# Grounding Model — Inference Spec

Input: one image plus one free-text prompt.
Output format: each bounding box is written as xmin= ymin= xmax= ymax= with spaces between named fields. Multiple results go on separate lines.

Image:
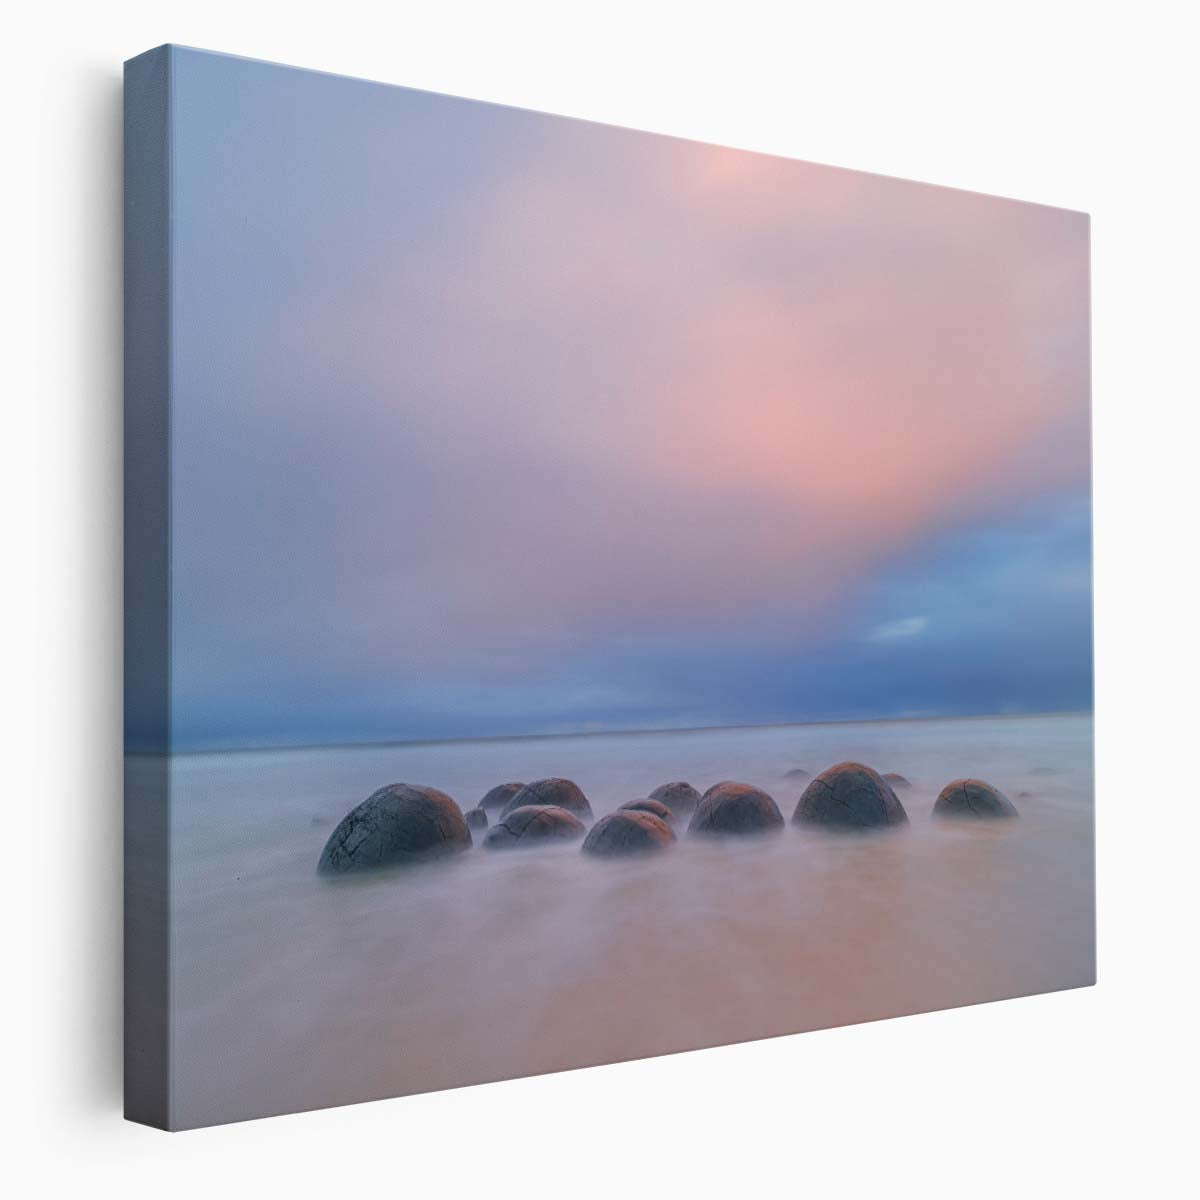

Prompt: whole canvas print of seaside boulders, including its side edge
xmin=126 ymin=47 xmax=1094 ymax=1129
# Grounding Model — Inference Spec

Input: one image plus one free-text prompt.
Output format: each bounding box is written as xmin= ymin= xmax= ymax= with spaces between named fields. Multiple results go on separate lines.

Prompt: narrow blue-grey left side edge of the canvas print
xmin=125 ymin=47 xmax=170 ymax=1128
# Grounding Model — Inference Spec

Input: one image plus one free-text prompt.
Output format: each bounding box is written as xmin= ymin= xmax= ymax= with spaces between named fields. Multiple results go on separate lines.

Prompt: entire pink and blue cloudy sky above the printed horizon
xmin=147 ymin=52 xmax=1092 ymax=749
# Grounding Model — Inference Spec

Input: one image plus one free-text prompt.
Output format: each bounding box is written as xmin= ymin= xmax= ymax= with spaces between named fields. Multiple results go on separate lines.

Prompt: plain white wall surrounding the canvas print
xmin=11 ymin=0 xmax=1200 ymax=1196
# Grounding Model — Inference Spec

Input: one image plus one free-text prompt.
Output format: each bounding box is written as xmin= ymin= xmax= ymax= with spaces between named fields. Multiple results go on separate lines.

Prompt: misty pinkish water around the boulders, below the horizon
xmin=159 ymin=715 xmax=1094 ymax=1126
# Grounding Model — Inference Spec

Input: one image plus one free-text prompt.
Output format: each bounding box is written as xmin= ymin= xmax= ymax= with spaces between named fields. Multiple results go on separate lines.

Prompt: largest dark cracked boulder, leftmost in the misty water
xmin=317 ymin=784 xmax=472 ymax=874
